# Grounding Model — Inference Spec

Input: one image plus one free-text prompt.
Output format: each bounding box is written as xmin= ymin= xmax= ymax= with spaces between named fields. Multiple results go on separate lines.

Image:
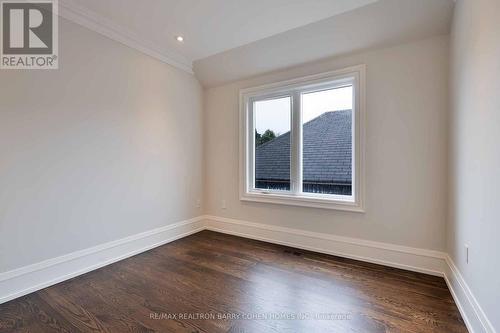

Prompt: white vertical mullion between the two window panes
xmin=290 ymin=91 xmax=302 ymax=195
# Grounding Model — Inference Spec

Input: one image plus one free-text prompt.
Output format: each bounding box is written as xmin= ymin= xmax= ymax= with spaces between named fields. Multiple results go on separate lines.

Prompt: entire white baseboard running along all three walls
xmin=0 ymin=215 xmax=496 ymax=333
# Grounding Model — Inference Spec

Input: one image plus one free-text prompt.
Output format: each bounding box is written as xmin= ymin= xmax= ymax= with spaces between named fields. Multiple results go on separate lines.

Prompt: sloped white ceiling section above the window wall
xmin=194 ymin=0 xmax=454 ymax=86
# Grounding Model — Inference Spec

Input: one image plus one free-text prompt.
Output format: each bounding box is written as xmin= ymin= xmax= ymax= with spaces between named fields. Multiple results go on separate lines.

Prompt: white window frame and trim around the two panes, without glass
xmin=239 ymin=65 xmax=366 ymax=212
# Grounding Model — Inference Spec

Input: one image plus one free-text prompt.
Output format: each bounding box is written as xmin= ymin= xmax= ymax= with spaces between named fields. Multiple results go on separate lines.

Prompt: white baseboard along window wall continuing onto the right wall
xmin=204 ymin=215 xmax=496 ymax=333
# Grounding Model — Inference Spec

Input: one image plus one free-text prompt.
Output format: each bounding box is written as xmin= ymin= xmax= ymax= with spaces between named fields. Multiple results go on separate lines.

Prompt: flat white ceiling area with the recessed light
xmin=60 ymin=0 xmax=377 ymax=67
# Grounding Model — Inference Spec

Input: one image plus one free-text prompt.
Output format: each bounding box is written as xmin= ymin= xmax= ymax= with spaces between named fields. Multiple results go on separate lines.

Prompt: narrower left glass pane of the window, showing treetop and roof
xmin=254 ymin=97 xmax=291 ymax=191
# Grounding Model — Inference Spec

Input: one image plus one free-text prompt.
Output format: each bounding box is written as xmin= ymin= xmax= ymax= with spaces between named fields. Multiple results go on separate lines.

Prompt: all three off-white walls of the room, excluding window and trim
xmin=0 ymin=4 xmax=500 ymax=330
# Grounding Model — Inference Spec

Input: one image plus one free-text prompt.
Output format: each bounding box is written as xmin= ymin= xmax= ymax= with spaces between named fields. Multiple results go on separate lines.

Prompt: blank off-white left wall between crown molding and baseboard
xmin=0 ymin=19 xmax=203 ymax=272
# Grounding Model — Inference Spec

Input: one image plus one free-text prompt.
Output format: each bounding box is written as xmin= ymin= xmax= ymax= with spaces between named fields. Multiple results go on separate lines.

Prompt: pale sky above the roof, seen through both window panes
xmin=254 ymin=86 xmax=352 ymax=135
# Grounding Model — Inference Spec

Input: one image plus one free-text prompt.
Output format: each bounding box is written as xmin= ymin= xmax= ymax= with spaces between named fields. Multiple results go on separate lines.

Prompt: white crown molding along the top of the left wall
xmin=59 ymin=0 xmax=194 ymax=74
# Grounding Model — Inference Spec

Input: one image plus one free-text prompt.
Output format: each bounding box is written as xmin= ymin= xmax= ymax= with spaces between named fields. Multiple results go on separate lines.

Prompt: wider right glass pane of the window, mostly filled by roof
xmin=302 ymin=86 xmax=353 ymax=195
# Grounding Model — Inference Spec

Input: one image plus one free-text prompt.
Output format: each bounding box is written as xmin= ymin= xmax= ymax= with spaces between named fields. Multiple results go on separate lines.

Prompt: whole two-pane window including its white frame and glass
xmin=240 ymin=66 xmax=365 ymax=211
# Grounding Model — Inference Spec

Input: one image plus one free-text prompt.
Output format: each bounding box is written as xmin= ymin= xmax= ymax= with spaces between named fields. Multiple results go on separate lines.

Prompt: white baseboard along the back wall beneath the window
xmin=205 ymin=216 xmax=446 ymax=276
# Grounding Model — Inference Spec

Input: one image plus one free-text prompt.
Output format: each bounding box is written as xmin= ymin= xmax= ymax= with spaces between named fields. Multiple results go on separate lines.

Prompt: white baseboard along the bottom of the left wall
xmin=0 ymin=217 xmax=204 ymax=304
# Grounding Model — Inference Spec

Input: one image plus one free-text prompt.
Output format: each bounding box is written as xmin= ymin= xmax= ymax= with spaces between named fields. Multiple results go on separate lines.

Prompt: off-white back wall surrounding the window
xmin=204 ymin=36 xmax=448 ymax=250
